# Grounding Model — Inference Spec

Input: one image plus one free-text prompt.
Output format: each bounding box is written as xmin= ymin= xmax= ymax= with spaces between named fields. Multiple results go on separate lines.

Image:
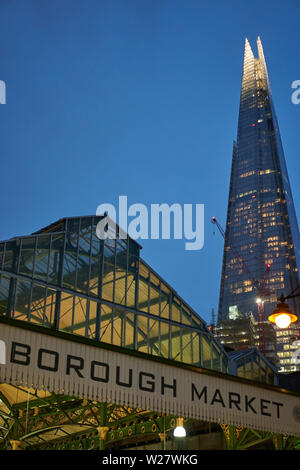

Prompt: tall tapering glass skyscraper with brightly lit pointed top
xmin=218 ymin=38 xmax=300 ymax=370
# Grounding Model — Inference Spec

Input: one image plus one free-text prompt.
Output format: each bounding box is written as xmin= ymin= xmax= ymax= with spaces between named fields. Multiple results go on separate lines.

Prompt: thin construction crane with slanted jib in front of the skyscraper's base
xmin=211 ymin=217 xmax=271 ymax=355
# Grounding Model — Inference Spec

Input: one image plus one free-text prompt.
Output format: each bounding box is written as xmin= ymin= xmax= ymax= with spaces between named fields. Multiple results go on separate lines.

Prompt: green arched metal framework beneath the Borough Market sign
xmin=0 ymin=384 xmax=300 ymax=450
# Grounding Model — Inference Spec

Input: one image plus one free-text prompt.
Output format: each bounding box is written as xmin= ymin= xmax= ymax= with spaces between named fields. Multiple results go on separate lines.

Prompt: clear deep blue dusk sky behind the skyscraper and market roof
xmin=0 ymin=0 xmax=300 ymax=322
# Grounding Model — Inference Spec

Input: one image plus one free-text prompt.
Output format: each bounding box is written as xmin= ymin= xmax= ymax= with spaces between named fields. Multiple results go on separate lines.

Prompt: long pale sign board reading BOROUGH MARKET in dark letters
xmin=0 ymin=323 xmax=300 ymax=436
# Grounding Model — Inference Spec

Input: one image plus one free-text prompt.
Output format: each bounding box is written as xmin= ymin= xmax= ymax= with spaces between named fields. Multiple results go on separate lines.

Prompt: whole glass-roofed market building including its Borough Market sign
xmin=0 ymin=216 xmax=300 ymax=449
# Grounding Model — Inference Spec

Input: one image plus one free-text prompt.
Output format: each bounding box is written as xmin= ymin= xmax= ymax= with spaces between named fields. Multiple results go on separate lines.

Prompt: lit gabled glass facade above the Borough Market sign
xmin=0 ymin=216 xmax=227 ymax=372
